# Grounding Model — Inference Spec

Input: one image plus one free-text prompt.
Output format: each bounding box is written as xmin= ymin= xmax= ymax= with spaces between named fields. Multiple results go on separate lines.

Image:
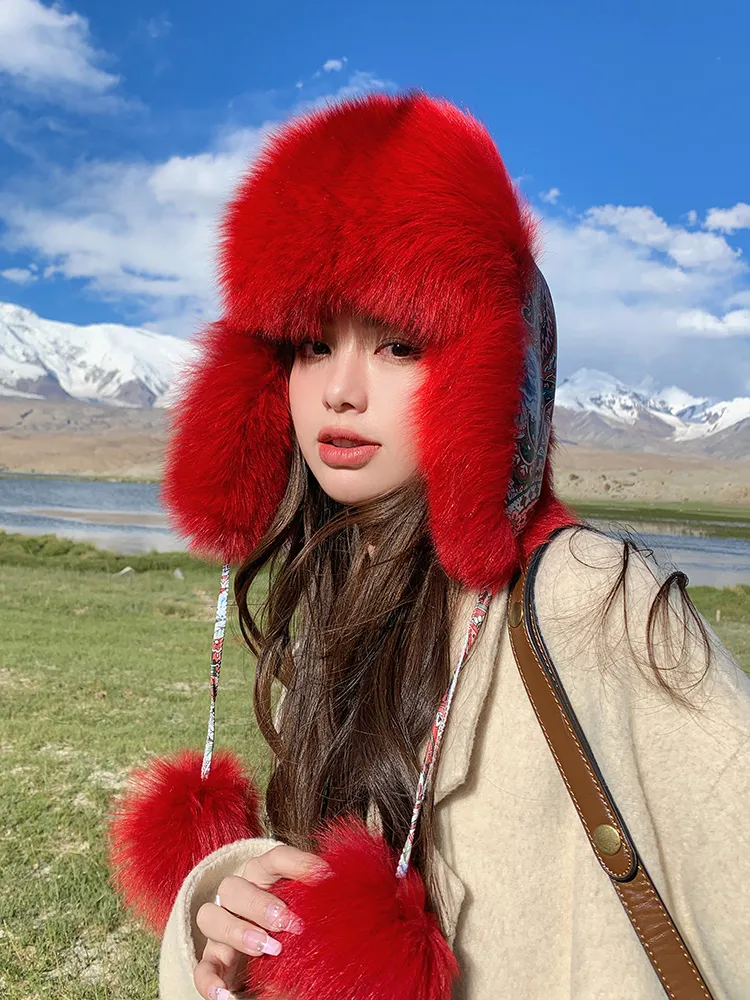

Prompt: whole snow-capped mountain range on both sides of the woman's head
xmin=0 ymin=303 xmax=750 ymax=459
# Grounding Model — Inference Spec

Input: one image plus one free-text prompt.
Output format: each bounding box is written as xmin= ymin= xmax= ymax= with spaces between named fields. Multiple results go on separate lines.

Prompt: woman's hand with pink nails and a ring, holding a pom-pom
xmin=193 ymin=844 xmax=327 ymax=1000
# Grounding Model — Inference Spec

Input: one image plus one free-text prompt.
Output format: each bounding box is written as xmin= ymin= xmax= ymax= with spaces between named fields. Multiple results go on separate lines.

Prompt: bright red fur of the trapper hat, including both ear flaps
xmin=162 ymin=92 xmax=572 ymax=588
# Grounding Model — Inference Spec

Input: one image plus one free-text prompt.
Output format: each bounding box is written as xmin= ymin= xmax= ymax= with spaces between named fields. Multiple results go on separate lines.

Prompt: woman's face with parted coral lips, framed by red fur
xmin=289 ymin=316 xmax=425 ymax=504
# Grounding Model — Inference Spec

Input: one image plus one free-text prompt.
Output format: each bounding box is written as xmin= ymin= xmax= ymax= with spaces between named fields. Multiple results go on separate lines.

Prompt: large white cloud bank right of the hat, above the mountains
xmin=540 ymin=205 xmax=750 ymax=398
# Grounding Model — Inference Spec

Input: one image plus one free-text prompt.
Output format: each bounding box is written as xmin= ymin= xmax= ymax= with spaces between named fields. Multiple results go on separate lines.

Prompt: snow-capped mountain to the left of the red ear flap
xmin=0 ymin=303 xmax=195 ymax=407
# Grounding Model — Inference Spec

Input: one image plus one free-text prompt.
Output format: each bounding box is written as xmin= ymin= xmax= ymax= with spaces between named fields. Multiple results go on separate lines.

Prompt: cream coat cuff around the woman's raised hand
xmin=159 ymin=837 xmax=280 ymax=1000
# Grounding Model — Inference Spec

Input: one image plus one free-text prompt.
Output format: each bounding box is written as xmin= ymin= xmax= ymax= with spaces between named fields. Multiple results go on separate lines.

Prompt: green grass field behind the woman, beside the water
xmin=0 ymin=533 xmax=750 ymax=1000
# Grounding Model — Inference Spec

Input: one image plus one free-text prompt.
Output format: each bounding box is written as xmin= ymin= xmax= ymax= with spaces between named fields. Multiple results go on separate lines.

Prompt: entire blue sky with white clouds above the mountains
xmin=0 ymin=0 xmax=750 ymax=398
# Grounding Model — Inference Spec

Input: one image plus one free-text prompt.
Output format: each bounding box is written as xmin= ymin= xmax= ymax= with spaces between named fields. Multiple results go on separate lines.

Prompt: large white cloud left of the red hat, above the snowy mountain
xmin=0 ymin=129 xmax=270 ymax=333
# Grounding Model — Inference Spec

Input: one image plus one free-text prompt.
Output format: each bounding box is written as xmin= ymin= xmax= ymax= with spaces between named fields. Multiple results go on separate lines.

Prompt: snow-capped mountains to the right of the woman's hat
xmin=555 ymin=368 xmax=750 ymax=458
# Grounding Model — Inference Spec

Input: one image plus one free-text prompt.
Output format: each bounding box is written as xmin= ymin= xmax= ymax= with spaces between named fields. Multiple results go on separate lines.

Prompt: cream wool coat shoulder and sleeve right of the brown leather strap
xmin=537 ymin=531 xmax=750 ymax=1000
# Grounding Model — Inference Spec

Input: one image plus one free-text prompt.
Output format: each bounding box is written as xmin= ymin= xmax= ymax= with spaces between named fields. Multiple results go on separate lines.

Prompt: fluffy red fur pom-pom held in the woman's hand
xmin=247 ymin=818 xmax=458 ymax=1000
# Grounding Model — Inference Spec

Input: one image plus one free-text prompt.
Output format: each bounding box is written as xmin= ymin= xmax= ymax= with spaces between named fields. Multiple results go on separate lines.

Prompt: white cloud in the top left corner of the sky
xmin=0 ymin=0 xmax=120 ymax=109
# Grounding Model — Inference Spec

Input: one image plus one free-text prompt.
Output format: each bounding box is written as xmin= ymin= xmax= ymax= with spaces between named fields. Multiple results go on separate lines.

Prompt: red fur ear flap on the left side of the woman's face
xmin=160 ymin=322 xmax=293 ymax=563
